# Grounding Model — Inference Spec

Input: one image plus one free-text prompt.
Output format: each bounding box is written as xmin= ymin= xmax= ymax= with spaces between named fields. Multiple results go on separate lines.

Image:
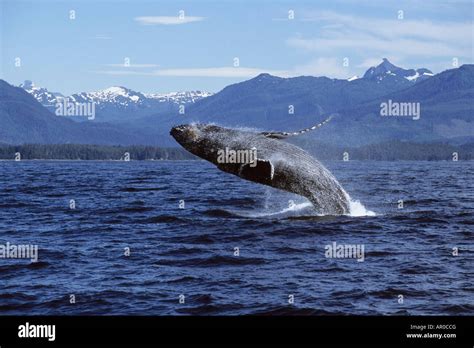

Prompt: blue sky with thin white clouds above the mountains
xmin=0 ymin=0 xmax=474 ymax=95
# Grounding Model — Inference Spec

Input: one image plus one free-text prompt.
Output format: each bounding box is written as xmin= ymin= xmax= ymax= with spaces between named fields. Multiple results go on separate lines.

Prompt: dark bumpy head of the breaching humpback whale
xmin=170 ymin=124 xmax=229 ymax=163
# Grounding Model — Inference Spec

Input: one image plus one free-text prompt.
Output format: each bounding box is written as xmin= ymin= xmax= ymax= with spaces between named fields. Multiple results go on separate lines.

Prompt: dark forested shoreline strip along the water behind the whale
xmin=0 ymin=139 xmax=474 ymax=162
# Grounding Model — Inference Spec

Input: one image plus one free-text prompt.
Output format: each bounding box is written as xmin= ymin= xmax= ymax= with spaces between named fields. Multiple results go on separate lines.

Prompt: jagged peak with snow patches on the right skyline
xmin=363 ymin=58 xmax=434 ymax=82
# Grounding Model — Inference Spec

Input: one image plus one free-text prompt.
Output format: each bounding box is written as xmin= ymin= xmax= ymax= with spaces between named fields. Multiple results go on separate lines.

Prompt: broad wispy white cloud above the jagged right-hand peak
xmin=287 ymin=11 xmax=474 ymax=59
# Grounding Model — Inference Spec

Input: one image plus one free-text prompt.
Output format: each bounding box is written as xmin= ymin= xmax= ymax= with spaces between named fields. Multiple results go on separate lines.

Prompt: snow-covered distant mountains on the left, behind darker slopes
xmin=20 ymin=81 xmax=212 ymax=122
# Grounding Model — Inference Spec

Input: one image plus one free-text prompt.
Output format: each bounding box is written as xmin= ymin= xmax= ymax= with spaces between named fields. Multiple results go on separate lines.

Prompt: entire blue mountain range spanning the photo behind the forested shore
xmin=0 ymin=59 xmax=474 ymax=147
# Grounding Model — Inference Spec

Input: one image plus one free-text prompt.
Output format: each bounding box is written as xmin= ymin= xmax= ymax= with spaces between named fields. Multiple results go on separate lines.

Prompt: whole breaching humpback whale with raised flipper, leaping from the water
xmin=170 ymin=118 xmax=350 ymax=215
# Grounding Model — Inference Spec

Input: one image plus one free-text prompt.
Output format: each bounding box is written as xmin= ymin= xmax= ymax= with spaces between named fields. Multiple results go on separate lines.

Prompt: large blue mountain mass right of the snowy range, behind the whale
xmin=180 ymin=59 xmax=474 ymax=146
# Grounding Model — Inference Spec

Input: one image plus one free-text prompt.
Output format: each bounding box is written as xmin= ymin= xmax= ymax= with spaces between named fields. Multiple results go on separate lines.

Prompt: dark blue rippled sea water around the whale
xmin=0 ymin=161 xmax=474 ymax=315
